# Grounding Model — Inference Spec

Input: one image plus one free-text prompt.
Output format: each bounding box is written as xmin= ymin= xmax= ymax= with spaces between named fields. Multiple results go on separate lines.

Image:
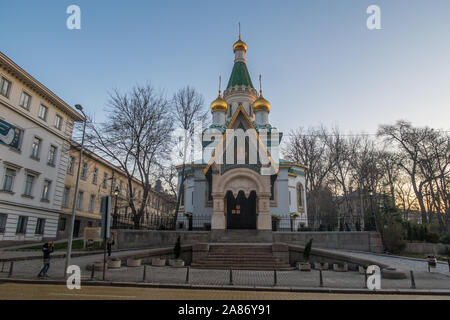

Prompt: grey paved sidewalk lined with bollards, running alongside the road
xmin=0 ymin=253 xmax=450 ymax=290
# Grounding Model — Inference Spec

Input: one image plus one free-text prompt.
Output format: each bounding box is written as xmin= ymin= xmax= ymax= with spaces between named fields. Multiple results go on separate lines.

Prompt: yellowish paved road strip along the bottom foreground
xmin=0 ymin=283 xmax=450 ymax=300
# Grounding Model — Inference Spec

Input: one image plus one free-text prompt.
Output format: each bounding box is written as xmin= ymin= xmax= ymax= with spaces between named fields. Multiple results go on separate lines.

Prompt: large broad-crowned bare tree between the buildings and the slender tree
xmin=86 ymin=85 xmax=173 ymax=228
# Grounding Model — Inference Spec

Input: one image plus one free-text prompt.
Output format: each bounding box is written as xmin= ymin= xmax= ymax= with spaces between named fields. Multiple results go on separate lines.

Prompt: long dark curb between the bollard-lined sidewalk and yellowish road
xmin=0 ymin=278 xmax=450 ymax=296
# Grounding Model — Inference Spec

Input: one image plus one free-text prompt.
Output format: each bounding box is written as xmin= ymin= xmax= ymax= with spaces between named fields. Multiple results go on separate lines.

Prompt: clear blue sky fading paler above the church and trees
xmin=0 ymin=0 xmax=450 ymax=133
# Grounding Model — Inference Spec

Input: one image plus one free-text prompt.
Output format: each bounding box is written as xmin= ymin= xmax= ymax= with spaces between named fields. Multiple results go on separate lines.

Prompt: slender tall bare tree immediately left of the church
xmin=172 ymin=86 xmax=208 ymax=225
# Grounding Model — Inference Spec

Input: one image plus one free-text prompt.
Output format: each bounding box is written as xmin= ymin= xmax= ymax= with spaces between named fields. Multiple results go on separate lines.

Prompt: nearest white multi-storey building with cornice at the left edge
xmin=0 ymin=52 xmax=84 ymax=241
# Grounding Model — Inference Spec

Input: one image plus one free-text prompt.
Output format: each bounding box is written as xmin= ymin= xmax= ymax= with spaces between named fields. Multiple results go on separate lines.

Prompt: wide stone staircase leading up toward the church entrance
xmin=191 ymin=244 xmax=294 ymax=270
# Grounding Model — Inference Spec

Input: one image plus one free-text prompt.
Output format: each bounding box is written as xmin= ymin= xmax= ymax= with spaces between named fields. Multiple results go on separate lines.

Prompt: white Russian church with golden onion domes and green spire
xmin=177 ymin=32 xmax=308 ymax=231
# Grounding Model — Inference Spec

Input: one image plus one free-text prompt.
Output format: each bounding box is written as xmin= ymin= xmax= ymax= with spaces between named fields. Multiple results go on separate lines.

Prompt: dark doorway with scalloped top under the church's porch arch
xmin=226 ymin=190 xmax=256 ymax=229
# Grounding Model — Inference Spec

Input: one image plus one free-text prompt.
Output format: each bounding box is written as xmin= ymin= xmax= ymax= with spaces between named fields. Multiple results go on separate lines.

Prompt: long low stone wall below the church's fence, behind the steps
xmin=117 ymin=230 xmax=383 ymax=252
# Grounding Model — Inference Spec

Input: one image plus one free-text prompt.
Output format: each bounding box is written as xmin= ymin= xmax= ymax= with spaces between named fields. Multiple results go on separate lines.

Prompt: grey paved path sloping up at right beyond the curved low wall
xmin=341 ymin=251 xmax=450 ymax=275
